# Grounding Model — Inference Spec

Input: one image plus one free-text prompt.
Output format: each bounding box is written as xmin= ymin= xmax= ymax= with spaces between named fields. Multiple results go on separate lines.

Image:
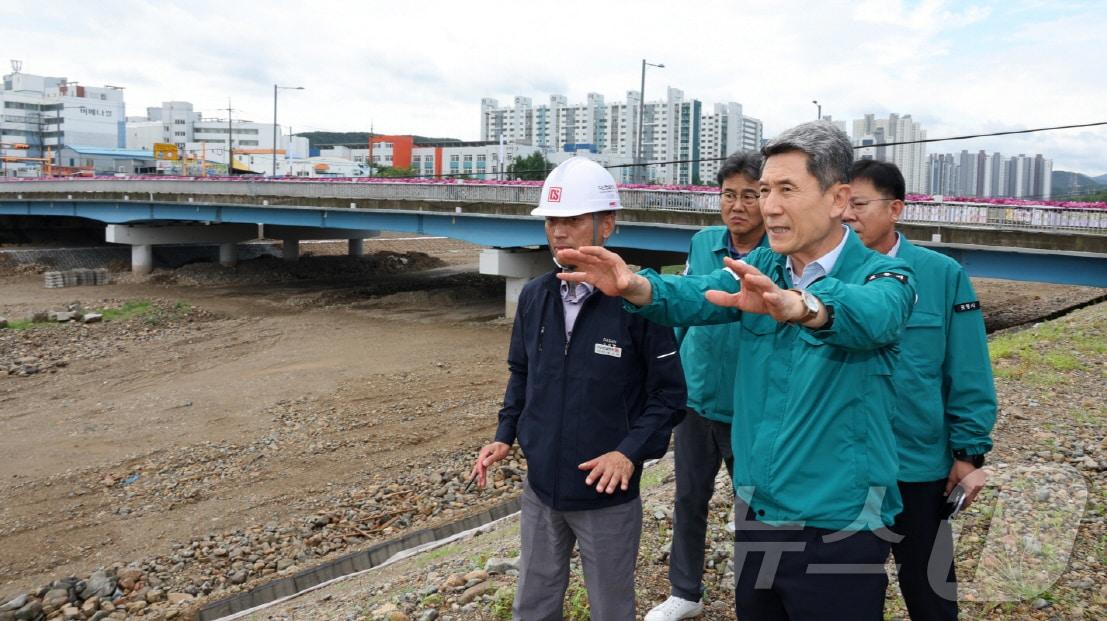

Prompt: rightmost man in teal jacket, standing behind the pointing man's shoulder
xmin=844 ymin=159 xmax=995 ymax=621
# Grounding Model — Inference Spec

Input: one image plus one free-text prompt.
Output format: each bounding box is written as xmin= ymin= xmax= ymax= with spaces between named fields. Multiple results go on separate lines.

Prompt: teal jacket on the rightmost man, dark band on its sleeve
xmin=892 ymin=236 xmax=995 ymax=483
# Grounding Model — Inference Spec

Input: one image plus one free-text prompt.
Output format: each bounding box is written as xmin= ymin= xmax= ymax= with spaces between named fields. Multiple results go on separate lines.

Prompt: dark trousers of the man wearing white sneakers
xmin=669 ymin=410 xmax=734 ymax=601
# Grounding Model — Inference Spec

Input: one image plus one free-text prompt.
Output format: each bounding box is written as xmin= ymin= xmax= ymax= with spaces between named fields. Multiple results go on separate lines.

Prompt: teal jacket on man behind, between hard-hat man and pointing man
xmin=676 ymin=226 xmax=768 ymax=425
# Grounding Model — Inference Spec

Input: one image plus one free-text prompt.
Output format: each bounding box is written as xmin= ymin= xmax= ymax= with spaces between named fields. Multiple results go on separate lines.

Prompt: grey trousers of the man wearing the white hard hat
xmin=511 ymin=482 xmax=642 ymax=621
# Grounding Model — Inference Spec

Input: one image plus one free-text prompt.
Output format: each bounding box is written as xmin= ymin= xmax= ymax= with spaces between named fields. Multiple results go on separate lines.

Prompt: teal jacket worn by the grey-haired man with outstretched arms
xmin=627 ymin=231 xmax=914 ymax=530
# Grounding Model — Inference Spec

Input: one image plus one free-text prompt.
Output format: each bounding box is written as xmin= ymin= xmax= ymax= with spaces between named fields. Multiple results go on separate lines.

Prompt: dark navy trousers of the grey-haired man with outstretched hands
xmin=734 ymin=503 xmax=890 ymax=621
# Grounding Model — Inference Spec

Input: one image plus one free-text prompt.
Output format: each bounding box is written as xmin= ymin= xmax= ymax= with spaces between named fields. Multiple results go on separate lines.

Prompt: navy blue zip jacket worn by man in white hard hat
xmin=496 ymin=272 xmax=686 ymax=510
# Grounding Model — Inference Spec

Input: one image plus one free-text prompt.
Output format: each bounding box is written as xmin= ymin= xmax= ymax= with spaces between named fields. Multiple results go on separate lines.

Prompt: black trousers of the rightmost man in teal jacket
xmin=892 ymin=478 xmax=958 ymax=621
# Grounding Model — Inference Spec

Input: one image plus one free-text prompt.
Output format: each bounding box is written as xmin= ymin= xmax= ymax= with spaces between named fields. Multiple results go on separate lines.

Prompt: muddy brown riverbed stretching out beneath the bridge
xmin=0 ymin=234 xmax=1104 ymax=615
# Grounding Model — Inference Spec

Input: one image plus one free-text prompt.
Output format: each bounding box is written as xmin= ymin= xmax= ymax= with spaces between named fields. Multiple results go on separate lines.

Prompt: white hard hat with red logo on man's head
xmin=530 ymin=156 xmax=622 ymax=218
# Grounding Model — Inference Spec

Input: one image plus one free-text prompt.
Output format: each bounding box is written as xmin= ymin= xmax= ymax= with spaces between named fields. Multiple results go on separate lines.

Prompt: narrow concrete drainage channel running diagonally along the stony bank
xmin=196 ymin=498 xmax=519 ymax=621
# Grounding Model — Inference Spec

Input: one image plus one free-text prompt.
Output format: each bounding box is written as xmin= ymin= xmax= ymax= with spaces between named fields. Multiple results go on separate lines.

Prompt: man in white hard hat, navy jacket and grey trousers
xmin=473 ymin=157 xmax=685 ymax=621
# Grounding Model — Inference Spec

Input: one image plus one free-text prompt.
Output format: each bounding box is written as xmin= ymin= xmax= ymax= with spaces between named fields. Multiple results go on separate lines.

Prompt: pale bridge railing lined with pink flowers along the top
xmin=0 ymin=178 xmax=1107 ymax=234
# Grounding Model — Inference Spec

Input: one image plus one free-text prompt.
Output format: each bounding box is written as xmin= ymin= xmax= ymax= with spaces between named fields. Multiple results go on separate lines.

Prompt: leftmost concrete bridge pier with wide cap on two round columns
xmin=104 ymin=224 xmax=258 ymax=275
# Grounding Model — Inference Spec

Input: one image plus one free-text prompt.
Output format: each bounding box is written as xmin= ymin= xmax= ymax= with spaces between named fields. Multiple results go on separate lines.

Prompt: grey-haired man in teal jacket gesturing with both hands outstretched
xmin=558 ymin=122 xmax=915 ymax=620
